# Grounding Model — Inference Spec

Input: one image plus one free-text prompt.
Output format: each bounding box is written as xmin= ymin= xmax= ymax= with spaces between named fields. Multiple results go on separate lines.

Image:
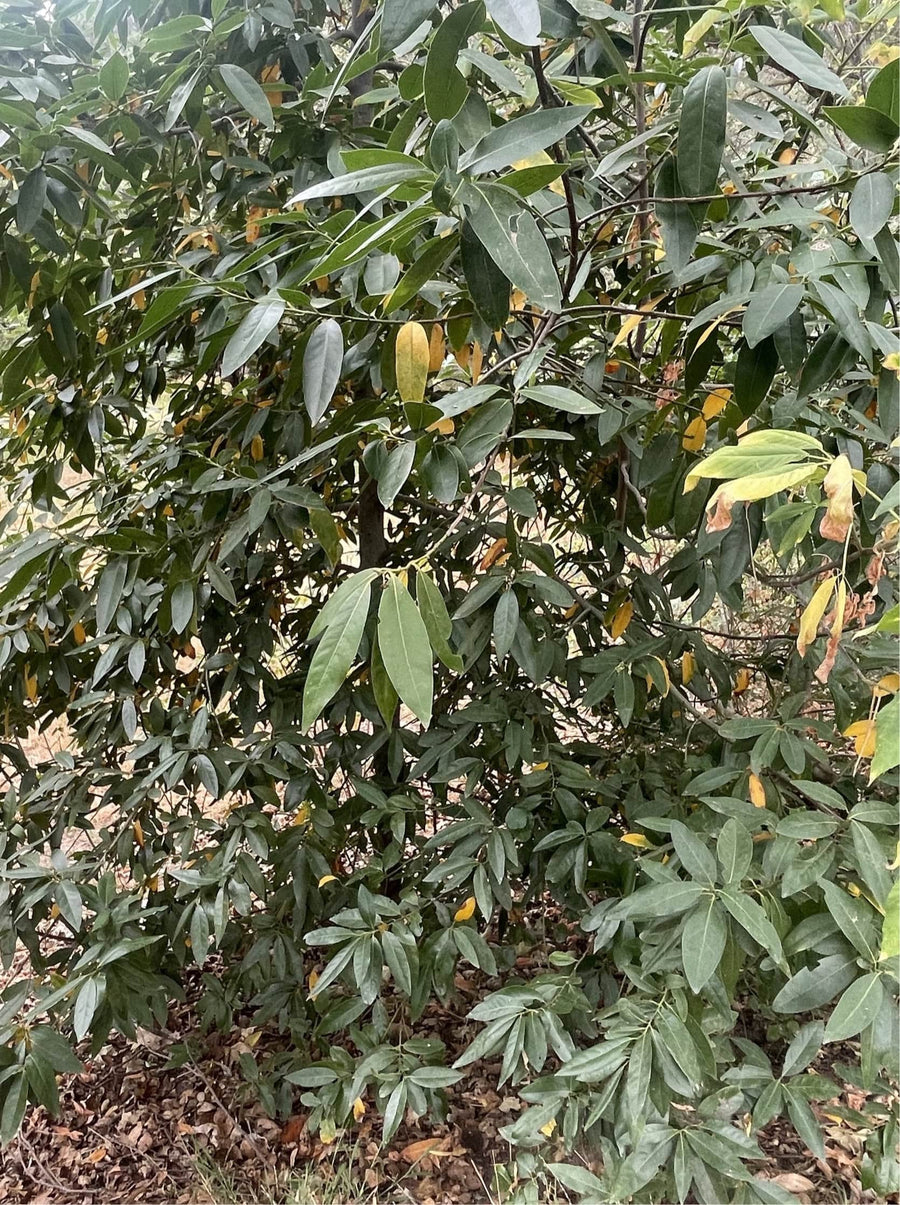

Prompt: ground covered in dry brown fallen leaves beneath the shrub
xmin=0 ymin=949 xmax=878 ymax=1205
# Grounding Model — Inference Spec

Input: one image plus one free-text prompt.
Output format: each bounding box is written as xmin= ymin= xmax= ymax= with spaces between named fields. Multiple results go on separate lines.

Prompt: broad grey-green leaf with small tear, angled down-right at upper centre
xmin=460 ymin=184 xmax=563 ymax=313
